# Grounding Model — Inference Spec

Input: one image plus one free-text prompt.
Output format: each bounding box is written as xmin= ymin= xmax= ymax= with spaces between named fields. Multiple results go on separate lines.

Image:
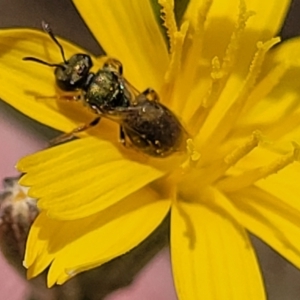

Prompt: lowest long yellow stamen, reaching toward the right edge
xmin=217 ymin=143 xmax=300 ymax=192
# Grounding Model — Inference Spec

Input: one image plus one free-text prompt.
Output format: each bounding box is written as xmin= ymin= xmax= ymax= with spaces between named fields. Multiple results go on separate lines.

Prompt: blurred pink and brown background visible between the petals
xmin=0 ymin=0 xmax=300 ymax=300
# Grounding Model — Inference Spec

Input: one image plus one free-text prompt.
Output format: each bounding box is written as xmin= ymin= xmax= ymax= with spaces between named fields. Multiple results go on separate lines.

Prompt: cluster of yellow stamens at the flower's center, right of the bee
xmin=159 ymin=0 xmax=300 ymax=204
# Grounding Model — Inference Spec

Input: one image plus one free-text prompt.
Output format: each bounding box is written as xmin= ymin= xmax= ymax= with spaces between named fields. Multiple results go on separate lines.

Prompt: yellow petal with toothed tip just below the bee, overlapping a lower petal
xmin=18 ymin=137 xmax=164 ymax=220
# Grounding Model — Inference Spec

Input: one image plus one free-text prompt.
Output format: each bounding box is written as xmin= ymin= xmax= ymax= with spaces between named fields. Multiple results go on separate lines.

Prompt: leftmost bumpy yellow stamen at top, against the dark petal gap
xmin=158 ymin=0 xmax=177 ymax=54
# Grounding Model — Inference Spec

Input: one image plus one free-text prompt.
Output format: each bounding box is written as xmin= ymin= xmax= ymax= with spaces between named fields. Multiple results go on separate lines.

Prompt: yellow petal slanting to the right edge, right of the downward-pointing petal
xmin=230 ymin=187 xmax=300 ymax=268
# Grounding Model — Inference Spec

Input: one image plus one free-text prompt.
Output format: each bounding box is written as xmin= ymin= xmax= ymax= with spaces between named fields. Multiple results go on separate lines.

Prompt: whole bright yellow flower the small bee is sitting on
xmin=0 ymin=0 xmax=300 ymax=300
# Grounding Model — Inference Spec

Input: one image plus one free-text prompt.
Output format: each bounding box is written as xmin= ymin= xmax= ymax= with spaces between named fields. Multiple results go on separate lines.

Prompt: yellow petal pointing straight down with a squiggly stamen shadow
xmin=171 ymin=191 xmax=265 ymax=300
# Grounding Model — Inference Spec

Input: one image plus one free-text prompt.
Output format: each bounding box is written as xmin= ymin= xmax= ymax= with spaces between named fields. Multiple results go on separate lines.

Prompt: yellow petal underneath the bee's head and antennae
xmin=0 ymin=29 xmax=104 ymax=131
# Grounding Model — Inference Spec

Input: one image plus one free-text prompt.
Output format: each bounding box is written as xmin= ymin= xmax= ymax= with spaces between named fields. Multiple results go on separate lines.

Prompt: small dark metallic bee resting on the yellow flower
xmin=23 ymin=22 xmax=186 ymax=157
